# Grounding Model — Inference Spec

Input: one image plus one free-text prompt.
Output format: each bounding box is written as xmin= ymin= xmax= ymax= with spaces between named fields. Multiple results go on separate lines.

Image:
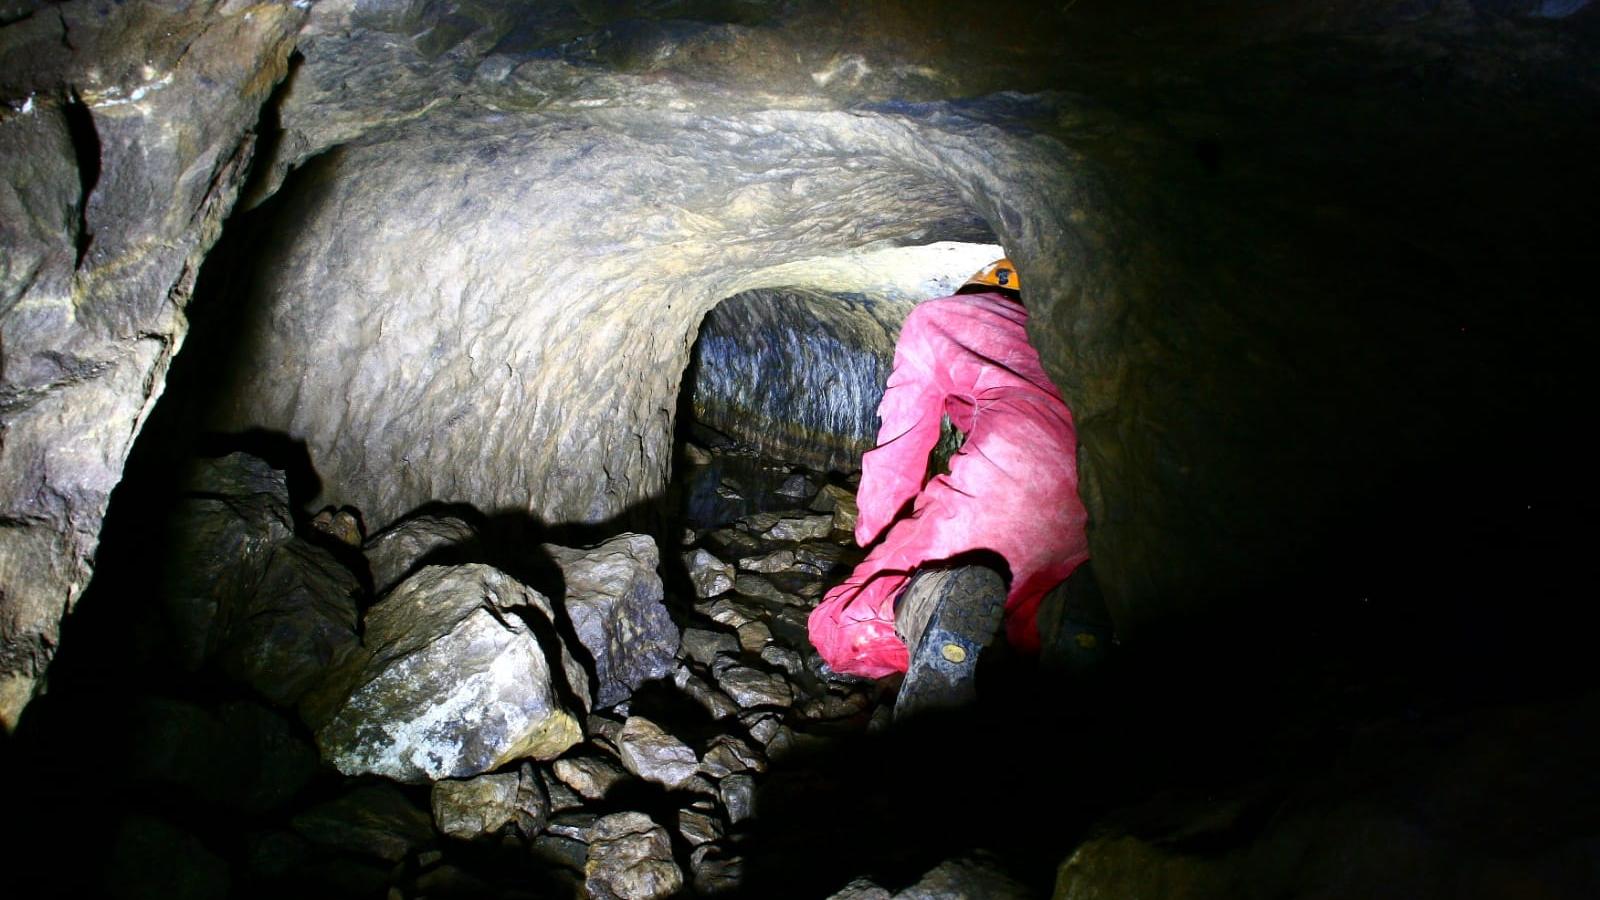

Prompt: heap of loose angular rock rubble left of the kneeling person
xmin=75 ymin=450 xmax=886 ymax=898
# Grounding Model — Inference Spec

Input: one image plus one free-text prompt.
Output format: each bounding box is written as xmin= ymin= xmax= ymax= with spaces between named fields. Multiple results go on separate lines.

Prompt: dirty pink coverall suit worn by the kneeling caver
xmin=808 ymin=293 xmax=1090 ymax=677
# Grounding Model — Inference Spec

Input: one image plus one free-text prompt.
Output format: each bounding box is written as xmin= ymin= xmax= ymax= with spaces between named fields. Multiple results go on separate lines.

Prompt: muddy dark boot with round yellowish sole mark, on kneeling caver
xmin=894 ymin=565 xmax=1006 ymax=721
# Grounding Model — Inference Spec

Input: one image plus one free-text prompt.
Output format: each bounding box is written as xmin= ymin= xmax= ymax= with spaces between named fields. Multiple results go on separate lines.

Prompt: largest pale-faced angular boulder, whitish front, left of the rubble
xmin=302 ymin=564 xmax=587 ymax=781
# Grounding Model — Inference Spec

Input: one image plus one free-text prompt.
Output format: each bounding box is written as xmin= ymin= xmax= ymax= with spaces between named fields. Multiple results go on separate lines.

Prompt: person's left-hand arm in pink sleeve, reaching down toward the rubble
xmin=856 ymin=312 xmax=946 ymax=546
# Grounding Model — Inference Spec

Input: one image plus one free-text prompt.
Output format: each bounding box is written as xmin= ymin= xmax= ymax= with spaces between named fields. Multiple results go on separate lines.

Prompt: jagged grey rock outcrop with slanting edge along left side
xmin=0 ymin=0 xmax=306 ymax=729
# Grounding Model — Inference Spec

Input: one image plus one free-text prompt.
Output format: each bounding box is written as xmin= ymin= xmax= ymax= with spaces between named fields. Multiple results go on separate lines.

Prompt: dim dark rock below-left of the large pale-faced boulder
xmin=291 ymin=785 xmax=434 ymax=862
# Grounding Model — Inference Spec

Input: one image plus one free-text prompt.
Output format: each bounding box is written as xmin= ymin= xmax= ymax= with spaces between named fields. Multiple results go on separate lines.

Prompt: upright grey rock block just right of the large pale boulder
xmin=544 ymin=535 xmax=678 ymax=709
